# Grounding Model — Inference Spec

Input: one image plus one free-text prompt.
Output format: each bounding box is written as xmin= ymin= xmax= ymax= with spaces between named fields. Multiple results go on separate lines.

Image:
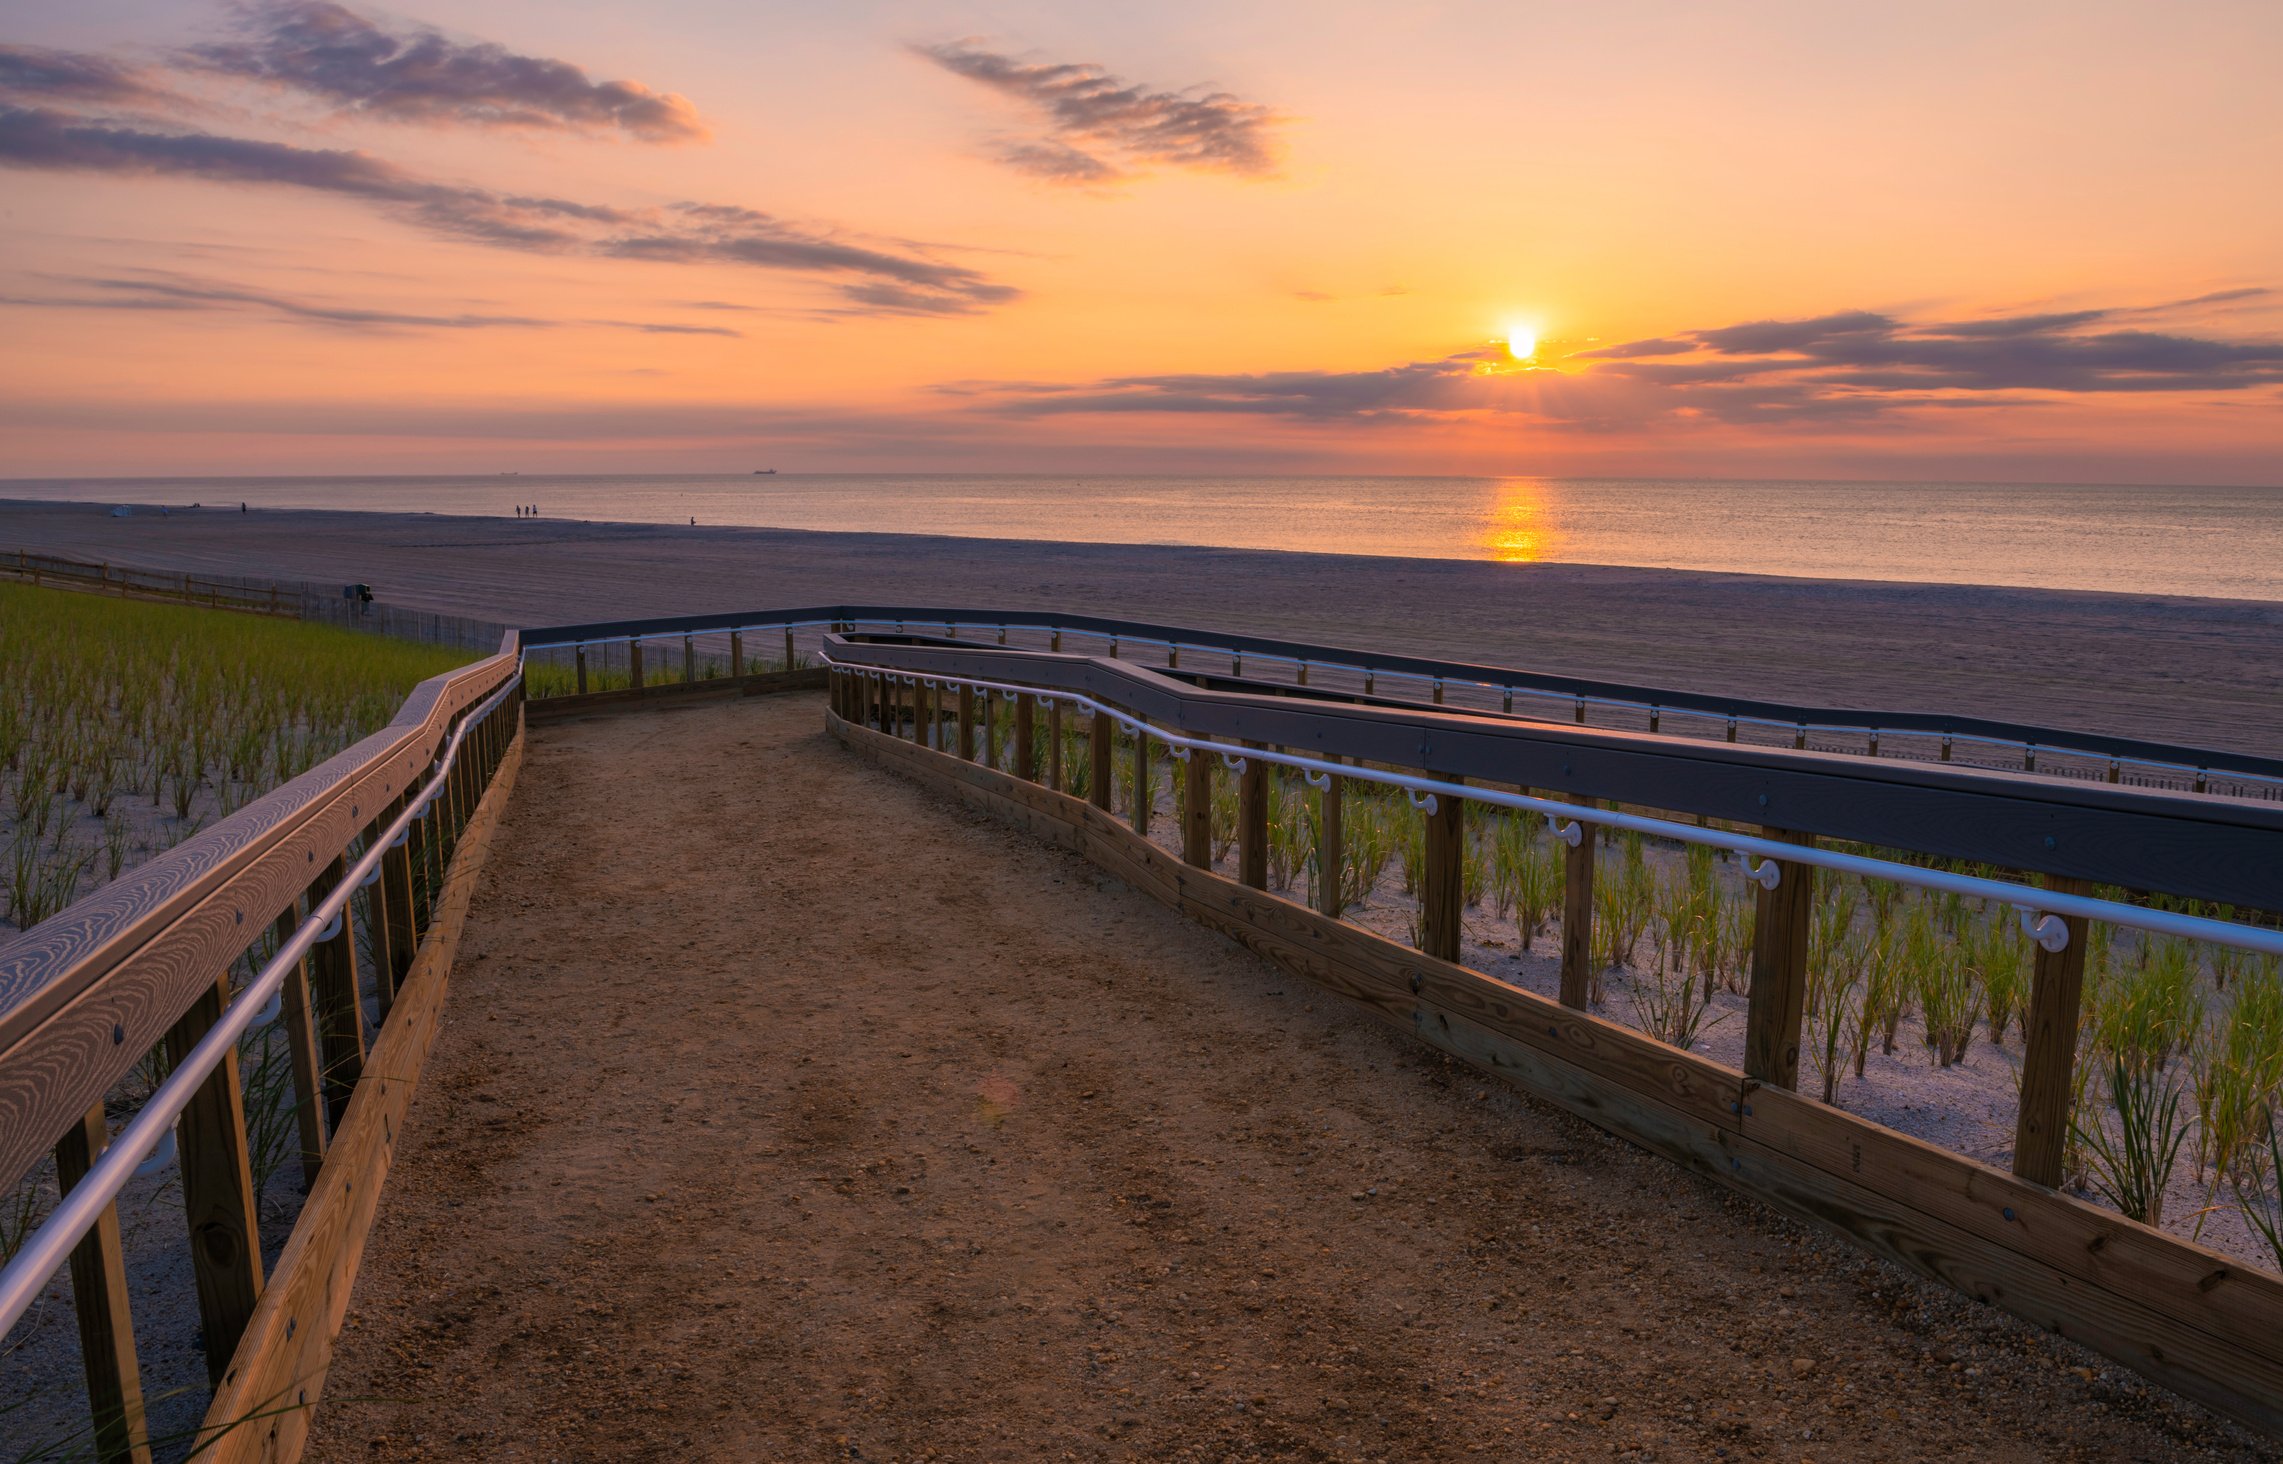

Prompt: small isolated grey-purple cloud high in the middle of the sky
xmin=911 ymin=41 xmax=1281 ymax=185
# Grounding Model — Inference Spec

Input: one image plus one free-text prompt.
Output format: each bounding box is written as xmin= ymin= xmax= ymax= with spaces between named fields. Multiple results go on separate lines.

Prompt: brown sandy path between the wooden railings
xmin=294 ymin=697 xmax=2251 ymax=1462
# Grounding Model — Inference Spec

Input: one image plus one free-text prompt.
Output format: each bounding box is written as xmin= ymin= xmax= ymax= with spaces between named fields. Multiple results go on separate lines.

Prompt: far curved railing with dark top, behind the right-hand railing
xmin=523 ymin=605 xmax=2283 ymax=802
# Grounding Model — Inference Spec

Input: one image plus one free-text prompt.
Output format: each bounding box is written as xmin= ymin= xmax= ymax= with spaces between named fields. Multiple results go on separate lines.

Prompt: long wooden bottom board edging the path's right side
xmin=833 ymin=719 xmax=2283 ymax=1432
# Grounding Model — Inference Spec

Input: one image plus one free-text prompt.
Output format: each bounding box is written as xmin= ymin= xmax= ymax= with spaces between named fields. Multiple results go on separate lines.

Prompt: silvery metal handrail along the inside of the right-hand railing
xmin=822 ymin=649 xmax=2283 ymax=957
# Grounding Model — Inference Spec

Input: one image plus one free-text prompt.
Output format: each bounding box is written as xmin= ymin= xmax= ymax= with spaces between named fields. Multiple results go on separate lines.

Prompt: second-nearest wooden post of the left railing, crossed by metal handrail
xmin=167 ymin=971 xmax=263 ymax=1384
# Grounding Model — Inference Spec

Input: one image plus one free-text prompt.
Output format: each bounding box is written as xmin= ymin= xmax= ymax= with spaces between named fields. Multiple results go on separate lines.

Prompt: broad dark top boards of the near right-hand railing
xmin=824 ymin=635 xmax=2283 ymax=911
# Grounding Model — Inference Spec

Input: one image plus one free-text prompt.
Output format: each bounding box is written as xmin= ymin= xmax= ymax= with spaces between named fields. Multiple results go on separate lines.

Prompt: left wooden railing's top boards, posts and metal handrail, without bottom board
xmin=0 ymin=635 xmax=523 ymax=1459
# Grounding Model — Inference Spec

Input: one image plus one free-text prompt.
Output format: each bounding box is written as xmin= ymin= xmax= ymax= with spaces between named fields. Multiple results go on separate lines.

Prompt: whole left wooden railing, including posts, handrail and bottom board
xmin=0 ymin=635 xmax=521 ymax=1459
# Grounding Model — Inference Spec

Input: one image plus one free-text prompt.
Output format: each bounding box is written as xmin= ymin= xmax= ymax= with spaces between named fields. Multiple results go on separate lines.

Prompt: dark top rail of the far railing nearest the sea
xmin=523 ymin=605 xmax=2283 ymax=795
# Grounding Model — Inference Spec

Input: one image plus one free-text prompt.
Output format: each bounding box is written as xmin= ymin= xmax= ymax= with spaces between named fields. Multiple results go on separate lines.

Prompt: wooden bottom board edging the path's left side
xmin=201 ymin=712 xmax=523 ymax=1464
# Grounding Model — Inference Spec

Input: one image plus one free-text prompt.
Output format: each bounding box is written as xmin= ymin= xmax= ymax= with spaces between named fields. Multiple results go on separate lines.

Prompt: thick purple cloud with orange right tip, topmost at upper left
xmin=183 ymin=0 xmax=710 ymax=142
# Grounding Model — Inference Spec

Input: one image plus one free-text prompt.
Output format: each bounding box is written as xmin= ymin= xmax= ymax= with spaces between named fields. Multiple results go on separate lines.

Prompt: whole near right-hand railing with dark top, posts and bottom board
xmin=826 ymin=635 xmax=2283 ymax=1432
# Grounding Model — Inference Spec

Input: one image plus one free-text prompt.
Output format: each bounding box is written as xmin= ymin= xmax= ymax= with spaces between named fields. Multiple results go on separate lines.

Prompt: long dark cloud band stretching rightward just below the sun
xmin=963 ymin=295 xmax=2283 ymax=432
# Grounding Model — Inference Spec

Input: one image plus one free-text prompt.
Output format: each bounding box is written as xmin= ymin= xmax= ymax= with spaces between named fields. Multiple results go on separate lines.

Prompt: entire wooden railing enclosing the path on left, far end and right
xmin=0 ymin=605 xmax=2283 ymax=1457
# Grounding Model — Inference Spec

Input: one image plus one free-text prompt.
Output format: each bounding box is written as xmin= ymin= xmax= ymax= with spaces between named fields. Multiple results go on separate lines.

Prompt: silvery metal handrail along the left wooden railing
xmin=0 ymin=671 xmax=523 ymax=1336
